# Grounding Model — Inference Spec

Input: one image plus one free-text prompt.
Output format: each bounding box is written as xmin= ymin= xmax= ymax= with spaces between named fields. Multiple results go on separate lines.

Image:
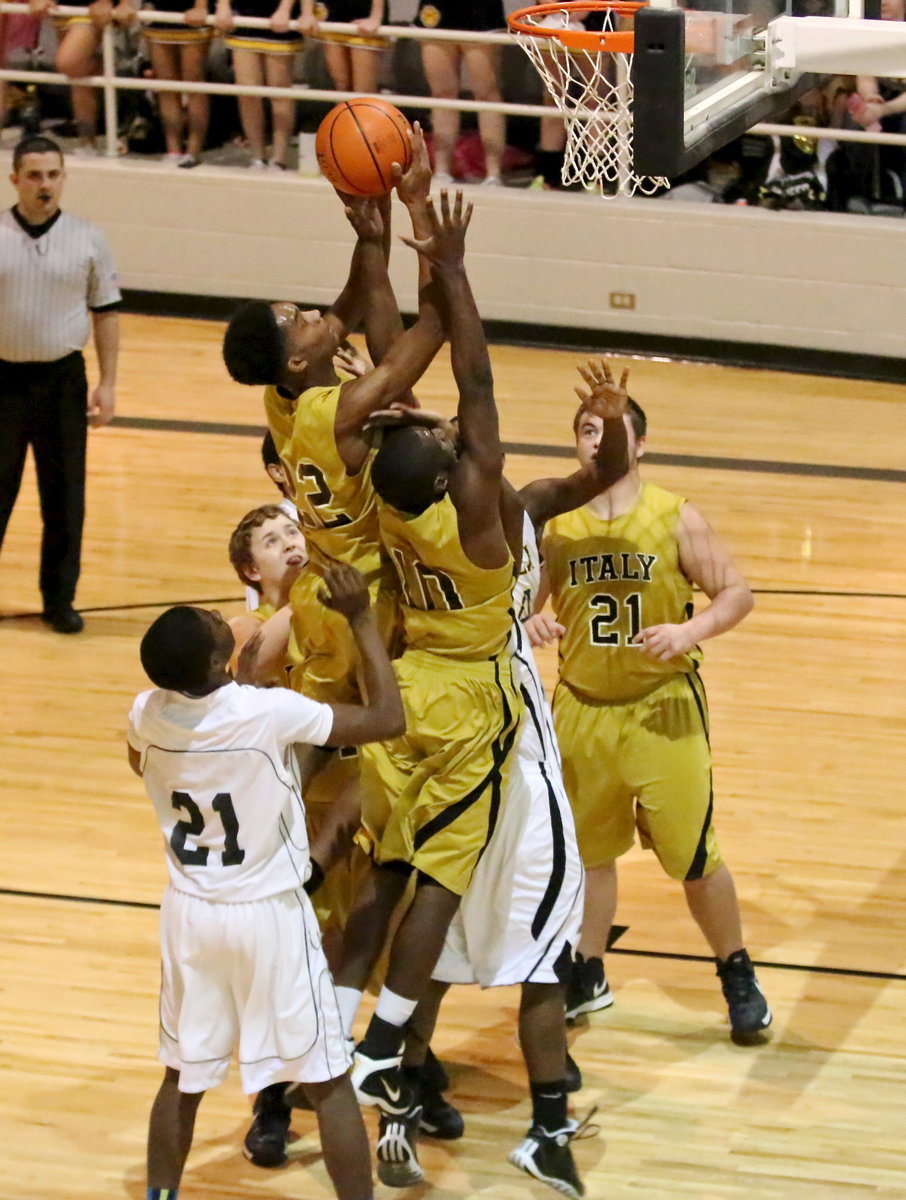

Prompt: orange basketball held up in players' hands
xmin=314 ymin=96 xmax=412 ymax=196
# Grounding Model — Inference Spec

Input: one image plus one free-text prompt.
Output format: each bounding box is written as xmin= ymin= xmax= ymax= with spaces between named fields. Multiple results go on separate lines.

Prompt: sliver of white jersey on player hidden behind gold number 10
xmin=510 ymin=512 xmax=560 ymax=769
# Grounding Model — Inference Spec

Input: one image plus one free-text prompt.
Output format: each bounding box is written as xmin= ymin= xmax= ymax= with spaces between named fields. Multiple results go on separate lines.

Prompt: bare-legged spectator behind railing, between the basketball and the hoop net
xmin=415 ymin=0 xmax=506 ymax=187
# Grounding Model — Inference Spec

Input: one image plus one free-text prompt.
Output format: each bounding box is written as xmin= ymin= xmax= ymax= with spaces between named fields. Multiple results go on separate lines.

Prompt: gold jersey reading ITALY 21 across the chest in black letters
xmin=544 ymin=484 xmax=702 ymax=701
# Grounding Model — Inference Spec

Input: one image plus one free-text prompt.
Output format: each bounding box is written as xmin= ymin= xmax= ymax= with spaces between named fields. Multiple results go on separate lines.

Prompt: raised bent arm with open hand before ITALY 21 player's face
xmin=520 ymin=359 xmax=629 ymax=529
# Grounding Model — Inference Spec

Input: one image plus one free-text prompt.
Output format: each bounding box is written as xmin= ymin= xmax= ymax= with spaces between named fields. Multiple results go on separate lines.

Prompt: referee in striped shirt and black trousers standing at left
xmin=0 ymin=137 xmax=121 ymax=634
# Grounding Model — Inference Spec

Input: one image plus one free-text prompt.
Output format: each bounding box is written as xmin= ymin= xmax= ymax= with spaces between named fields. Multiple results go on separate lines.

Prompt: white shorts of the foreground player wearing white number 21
xmin=158 ymin=888 xmax=349 ymax=1093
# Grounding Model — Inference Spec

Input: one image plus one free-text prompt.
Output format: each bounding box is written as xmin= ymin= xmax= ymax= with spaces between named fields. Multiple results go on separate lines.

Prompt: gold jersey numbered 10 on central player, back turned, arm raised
xmin=379 ymin=496 xmax=514 ymax=660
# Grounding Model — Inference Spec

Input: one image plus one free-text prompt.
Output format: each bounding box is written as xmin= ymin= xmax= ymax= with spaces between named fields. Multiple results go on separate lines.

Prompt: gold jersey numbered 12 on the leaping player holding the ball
xmin=264 ymin=383 xmax=380 ymax=580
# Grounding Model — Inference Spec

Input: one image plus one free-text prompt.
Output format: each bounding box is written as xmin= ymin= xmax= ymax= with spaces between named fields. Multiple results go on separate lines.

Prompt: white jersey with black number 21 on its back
xmin=128 ymin=683 xmax=334 ymax=902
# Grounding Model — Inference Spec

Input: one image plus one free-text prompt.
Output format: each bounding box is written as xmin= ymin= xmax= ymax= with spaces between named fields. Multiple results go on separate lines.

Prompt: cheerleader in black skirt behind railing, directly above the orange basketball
xmin=300 ymin=0 xmax=390 ymax=96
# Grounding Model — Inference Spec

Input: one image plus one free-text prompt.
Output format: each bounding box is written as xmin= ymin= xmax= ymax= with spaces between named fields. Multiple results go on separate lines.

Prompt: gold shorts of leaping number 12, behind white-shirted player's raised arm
xmin=289 ymin=563 xmax=398 ymax=703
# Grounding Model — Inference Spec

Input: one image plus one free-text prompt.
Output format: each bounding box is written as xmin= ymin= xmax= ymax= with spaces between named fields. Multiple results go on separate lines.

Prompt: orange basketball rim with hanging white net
xmin=508 ymin=0 xmax=668 ymax=197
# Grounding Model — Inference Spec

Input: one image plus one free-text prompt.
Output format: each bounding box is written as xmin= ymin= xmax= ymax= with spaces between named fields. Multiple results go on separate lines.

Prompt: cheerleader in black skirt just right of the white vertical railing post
xmin=144 ymin=0 xmax=214 ymax=167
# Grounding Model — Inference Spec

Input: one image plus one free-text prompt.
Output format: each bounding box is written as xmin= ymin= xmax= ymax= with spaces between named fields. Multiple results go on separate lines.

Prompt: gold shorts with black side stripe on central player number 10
xmin=359 ymin=650 xmax=522 ymax=895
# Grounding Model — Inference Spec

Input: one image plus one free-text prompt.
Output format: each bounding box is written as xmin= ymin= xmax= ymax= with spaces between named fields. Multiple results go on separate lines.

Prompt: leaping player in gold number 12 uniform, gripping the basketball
xmin=223 ymin=127 xmax=443 ymax=698
